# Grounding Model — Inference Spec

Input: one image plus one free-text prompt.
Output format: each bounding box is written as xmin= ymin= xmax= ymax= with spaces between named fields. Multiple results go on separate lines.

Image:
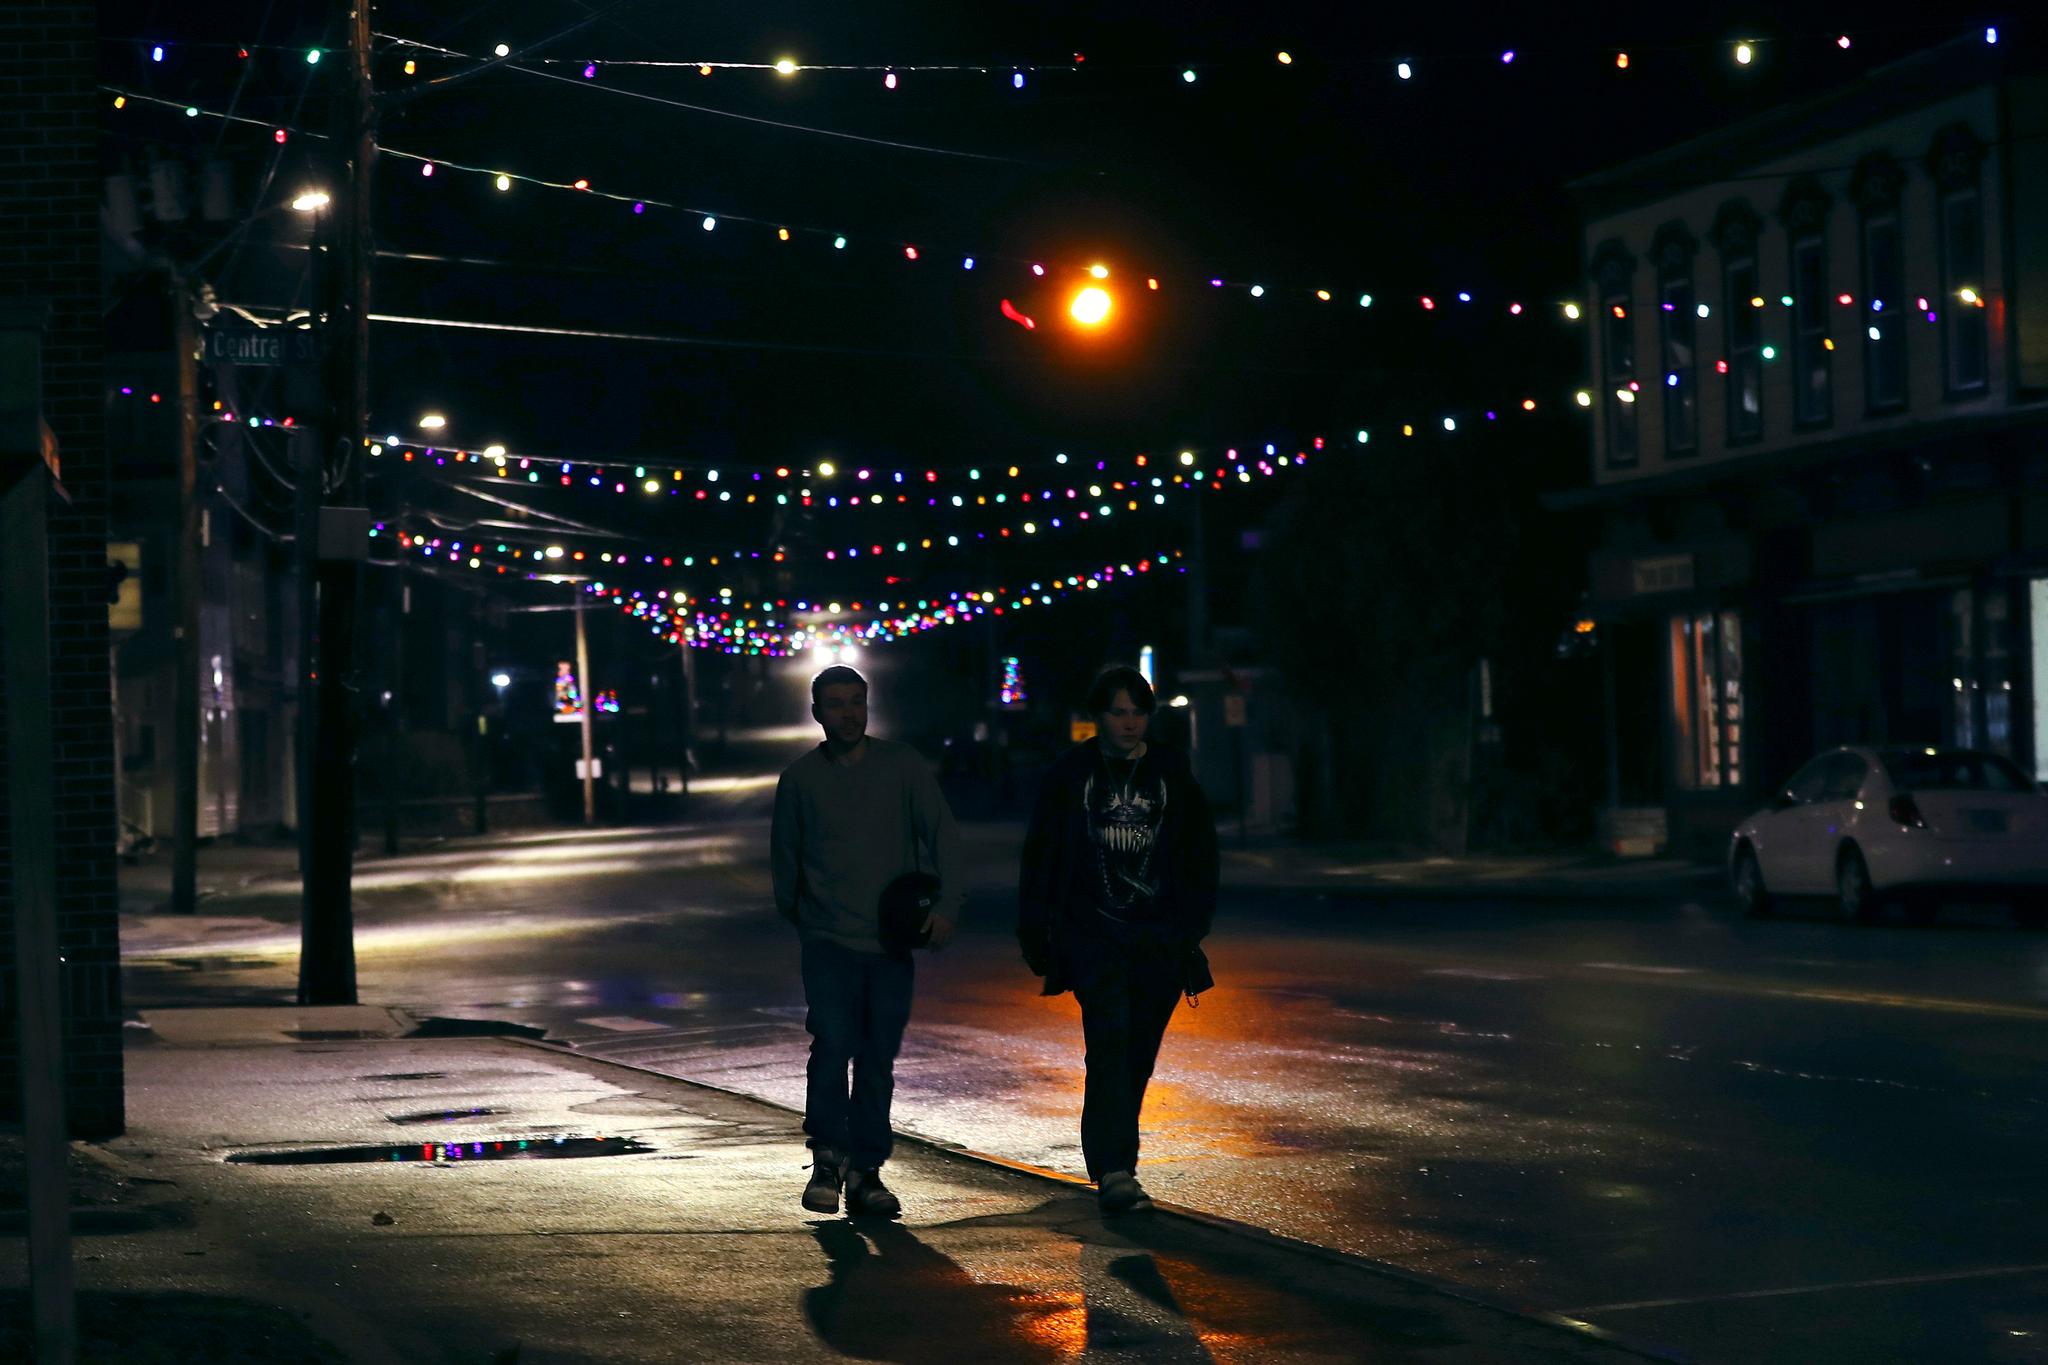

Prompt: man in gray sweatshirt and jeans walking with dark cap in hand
xmin=770 ymin=667 xmax=963 ymax=1218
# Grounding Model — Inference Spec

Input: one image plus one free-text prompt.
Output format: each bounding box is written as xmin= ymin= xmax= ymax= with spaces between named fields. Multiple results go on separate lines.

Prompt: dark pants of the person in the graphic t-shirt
xmin=1067 ymin=917 xmax=1184 ymax=1181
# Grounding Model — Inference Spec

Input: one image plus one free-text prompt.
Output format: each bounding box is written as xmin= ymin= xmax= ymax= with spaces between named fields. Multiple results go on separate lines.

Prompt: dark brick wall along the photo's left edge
xmin=0 ymin=0 xmax=123 ymax=1138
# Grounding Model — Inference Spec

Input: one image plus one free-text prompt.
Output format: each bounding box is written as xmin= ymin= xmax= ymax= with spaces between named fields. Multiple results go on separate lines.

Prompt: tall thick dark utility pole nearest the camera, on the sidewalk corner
xmin=299 ymin=0 xmax=377 ymax=1005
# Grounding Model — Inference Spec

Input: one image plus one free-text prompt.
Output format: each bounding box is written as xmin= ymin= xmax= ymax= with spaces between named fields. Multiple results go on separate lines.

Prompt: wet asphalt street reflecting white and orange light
xmin=127 ymin=802 xmax=2048 ymax=1365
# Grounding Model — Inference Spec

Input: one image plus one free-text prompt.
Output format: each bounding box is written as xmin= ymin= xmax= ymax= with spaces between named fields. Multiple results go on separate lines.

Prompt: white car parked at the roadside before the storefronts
xmin=1729 ymin=745 xmax=2048 ymax=927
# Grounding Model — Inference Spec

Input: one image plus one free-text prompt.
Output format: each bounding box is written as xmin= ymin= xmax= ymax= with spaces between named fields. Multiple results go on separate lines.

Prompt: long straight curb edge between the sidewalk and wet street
xmin=504 ymin=1038 xmax=1696 ymax=1365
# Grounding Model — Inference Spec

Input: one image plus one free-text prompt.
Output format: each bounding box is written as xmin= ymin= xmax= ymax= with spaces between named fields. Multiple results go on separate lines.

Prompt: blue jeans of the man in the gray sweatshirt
xmin=803 ymin=939 xmax=918 ymax=1171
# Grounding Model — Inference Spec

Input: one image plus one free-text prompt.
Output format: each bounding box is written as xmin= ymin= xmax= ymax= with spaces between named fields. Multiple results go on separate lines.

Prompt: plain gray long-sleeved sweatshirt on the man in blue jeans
xmin=768 ymin=735 xmax=965 ymax=952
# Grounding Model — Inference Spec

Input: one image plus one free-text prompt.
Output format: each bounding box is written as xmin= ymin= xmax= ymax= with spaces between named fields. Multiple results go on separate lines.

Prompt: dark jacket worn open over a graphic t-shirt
xmin=1018 ymin=741 xmax=1217 ymax=995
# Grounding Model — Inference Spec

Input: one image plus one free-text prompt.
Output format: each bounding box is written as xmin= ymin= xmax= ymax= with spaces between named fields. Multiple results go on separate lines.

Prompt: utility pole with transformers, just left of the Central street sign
xmin=170 ymin=270 xmax=199 ymax=915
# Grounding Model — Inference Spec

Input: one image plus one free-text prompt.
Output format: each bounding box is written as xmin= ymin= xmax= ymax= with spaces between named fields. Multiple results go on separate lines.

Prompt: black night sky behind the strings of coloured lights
xmin=102 ymin=0 xmax=1999 ymax=695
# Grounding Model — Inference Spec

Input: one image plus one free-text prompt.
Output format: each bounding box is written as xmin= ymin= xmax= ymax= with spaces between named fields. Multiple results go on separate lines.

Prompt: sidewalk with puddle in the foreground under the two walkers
xmin=0 ymin=1007 xmax=1667 ymax=1365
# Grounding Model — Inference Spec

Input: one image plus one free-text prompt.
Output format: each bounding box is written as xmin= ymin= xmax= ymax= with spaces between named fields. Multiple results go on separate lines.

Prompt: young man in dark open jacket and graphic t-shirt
xmin=1018 ymin=667 xmax=1217 ymax=1216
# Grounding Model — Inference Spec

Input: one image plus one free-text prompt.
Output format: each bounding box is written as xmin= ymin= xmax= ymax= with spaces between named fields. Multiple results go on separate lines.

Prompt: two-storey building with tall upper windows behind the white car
xmin=1552 ymin=39 xmax=2048 ymax=853
